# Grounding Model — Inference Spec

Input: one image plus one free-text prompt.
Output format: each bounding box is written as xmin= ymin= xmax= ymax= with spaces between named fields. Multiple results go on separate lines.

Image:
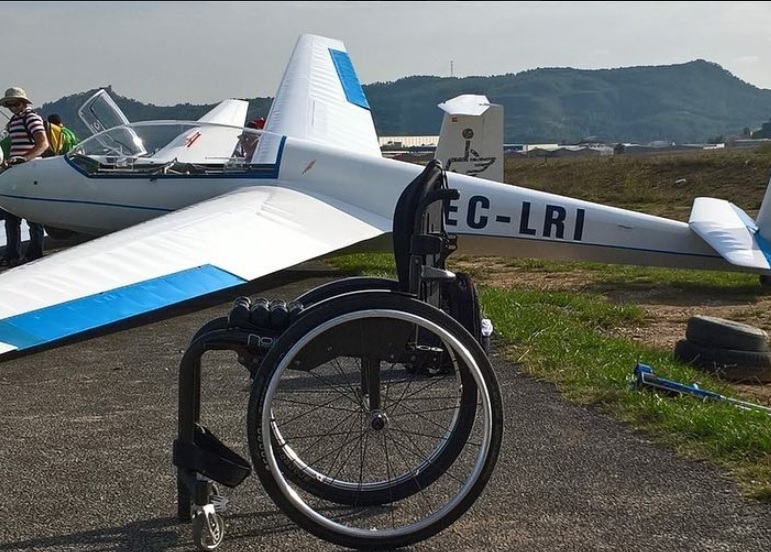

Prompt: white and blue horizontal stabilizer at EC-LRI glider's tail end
xmin=688 ymin=197 xmax=771 ymax=270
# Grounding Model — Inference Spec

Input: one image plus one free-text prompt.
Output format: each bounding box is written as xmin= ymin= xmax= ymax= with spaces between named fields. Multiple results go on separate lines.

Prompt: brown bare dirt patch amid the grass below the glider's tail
xmin=452 ymin=257 xmax=771 ymax=406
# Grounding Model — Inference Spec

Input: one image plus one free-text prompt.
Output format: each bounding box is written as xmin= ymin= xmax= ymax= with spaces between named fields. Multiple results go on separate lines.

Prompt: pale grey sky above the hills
xmin=0 ymin=1 xmax=771 ymax=106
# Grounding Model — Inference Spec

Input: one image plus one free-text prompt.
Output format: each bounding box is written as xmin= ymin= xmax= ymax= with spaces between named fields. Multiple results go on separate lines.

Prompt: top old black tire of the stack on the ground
xmin=685 ymin=315 xmax=769 ymax=353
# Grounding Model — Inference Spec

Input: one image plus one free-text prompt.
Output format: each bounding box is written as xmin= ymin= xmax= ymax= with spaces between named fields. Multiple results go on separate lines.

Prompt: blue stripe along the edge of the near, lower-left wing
xmin=0 ymin=265 xmax=246 ymax=350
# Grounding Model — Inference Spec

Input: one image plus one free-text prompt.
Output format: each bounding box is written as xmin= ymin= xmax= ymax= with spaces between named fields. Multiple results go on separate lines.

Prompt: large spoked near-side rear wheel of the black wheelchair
xmin=247 ymin=291 xmax=503 ymax=549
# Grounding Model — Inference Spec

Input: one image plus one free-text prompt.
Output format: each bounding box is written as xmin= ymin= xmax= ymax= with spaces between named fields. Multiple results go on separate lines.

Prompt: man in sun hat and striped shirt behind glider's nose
xmin=0 ymin=87 xmax=48 ymax=266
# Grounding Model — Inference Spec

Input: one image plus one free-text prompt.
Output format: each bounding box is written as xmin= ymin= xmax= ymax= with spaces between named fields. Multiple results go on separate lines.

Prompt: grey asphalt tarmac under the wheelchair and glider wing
xmin=0 ymin=265 xmax=771 ymax=552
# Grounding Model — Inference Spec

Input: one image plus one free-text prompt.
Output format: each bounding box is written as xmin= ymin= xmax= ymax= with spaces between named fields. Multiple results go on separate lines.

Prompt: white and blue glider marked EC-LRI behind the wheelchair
xmin=0 ymin=35 xmax=771 ymax=359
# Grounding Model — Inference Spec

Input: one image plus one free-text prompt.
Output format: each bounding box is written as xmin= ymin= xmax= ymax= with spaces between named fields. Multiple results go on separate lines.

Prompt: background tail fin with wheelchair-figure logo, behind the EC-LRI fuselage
xmin=435 ymin=94 xmax=503 ymax=182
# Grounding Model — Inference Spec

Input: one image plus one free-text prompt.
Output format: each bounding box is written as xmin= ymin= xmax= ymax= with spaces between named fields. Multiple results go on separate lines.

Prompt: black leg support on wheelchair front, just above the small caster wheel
xmin=173 ymin=425 xmax=252 ymax=487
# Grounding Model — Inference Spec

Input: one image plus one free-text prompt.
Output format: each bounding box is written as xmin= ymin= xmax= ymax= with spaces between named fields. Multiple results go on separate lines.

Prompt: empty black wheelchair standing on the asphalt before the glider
xmin=173 ymin=161 xmax=503 ymax=550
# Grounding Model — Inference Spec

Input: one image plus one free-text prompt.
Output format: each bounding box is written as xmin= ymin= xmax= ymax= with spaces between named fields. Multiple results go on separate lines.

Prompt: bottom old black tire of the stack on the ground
xmin=674 ymin=339 xmax=771 ymax=383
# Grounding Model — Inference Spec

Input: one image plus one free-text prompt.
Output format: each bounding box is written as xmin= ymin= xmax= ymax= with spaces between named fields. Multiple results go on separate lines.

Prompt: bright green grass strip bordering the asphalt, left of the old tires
xmin=482 ymin=280 xmax=771 ymax=501
